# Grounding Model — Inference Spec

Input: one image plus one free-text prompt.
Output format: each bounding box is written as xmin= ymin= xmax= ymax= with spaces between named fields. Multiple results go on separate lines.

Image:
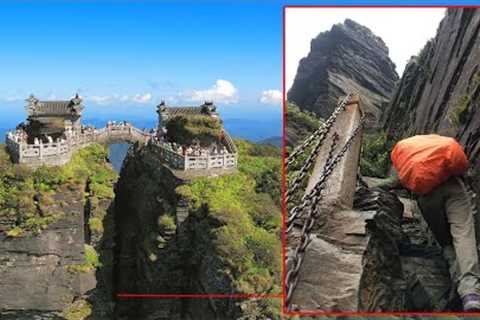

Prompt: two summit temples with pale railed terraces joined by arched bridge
xmin=5 ymin=94 xmax=237 ymax=170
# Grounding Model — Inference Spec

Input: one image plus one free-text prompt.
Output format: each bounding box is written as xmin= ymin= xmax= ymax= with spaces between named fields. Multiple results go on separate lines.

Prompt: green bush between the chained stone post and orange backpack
xmin=360 ymin=132 xmax=394 ymax=178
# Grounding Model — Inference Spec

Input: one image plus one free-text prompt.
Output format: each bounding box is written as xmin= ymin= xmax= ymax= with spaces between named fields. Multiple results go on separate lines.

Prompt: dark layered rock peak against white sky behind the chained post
xmin=288 ymin=19 xmax=398 ymax=127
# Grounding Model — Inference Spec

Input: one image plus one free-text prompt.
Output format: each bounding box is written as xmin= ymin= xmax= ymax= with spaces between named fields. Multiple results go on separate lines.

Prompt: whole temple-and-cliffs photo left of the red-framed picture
xmin=0 ymin=0 xmax=283 ymax=320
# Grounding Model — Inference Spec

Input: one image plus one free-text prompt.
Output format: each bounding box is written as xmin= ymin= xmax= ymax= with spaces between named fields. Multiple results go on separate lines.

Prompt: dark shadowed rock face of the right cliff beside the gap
xmin=115 ymin=146 xmax=240 ymax=320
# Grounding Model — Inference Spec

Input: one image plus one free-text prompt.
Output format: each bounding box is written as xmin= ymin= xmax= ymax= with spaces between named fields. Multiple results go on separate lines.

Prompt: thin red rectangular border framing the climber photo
xmin=282 ymin=5 xmax=480 ymax=317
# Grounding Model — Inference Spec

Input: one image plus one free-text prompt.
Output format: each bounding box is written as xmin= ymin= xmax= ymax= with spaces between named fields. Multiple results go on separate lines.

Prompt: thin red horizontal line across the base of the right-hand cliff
xmin=117 ymin=293 xmax=283 ymax=299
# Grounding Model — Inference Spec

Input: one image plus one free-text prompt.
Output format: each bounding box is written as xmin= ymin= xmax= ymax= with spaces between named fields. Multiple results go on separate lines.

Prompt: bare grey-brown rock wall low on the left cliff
xmin=0 ymin=185 xmax=94 ymax=319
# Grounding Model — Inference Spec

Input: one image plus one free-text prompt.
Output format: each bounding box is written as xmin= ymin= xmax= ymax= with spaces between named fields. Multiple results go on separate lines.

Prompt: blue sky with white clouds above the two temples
xmin=0 ymin=1 xmax=282 ymax=138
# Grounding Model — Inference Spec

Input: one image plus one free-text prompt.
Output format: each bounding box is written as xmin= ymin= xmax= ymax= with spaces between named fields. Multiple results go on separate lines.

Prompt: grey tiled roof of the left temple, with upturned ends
xmin=26 ymin=95 xmax=83 ymax=117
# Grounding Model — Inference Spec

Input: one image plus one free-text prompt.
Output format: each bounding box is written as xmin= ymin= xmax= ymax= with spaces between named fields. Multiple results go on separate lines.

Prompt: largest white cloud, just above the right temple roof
xmin=182 ymin=79 xmax=238 ymax=104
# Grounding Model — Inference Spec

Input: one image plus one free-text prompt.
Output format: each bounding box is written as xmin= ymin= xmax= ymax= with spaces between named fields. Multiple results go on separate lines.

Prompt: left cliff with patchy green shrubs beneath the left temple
xmin=0 ymin=145 xmax=116 ymax=320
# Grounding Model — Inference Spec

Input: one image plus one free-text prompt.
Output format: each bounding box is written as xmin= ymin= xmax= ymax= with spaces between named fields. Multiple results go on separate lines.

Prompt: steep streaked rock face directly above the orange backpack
xmin=382 ymin=9 xmax=480 ymax=185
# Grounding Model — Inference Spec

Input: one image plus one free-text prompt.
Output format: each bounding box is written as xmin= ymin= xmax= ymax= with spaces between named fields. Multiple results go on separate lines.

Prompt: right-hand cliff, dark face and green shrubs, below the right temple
xmin=115 ymin=141 xmax=281 ymax=320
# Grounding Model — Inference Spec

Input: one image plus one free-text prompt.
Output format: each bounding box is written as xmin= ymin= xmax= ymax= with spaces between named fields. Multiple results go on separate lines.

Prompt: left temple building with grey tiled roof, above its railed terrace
xmin=24 ymin=94 xmax=84 ymax=143
